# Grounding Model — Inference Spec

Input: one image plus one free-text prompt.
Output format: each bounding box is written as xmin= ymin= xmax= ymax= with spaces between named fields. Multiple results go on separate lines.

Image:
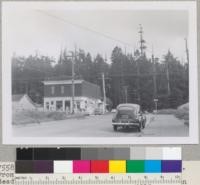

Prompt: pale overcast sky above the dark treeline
xmin=4 ymin=4 xmax=188 ymax=62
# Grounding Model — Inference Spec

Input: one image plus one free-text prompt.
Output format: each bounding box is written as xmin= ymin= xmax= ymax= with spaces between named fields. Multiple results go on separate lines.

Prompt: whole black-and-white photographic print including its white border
xmin=2 ymin=1 xmax=198 ymax=144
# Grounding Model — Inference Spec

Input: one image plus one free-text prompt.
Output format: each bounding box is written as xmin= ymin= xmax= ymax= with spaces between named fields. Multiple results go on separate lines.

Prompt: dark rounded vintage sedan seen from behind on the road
xmin=112 ymin=103 xmax=146 ymax=132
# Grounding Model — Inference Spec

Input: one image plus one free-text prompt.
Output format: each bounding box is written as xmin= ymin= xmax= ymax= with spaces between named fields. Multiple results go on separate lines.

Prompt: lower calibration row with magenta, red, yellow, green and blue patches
xmin=15 ymin=160 xmax=182 ymax=173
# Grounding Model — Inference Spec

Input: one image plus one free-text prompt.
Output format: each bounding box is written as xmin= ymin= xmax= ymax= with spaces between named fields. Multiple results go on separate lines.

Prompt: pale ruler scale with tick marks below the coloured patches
xmin=15 ymin=174 xmax=181 ymax=185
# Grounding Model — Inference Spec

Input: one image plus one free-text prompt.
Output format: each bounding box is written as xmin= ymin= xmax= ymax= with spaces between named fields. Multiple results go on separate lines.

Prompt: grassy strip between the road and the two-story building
xmin=12 ymin=110 xmax=85 ymax=125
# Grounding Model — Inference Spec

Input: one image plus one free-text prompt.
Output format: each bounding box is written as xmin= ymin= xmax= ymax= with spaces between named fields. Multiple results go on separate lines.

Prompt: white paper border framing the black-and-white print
xmin=2 ymin=1 xmax=199 ymax=145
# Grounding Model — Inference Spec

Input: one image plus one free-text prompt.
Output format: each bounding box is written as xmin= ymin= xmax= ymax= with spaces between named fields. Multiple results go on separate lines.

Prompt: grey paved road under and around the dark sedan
xmin=13 ymin=114 xmax=189 ymax=137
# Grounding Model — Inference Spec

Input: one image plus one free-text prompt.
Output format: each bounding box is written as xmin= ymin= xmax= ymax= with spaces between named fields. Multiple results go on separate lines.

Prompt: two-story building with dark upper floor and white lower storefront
xmin=43 ymin=80 xmax=102 ymax=114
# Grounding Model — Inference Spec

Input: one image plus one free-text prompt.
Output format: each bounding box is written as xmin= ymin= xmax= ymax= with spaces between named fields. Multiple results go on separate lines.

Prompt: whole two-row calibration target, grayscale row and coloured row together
xmin=16 ymin=147 xmax=182 ymax=173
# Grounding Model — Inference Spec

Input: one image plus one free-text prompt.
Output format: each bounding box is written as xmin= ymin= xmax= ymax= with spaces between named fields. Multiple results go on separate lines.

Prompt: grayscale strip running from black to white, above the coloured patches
xmin=16 ymin=147 xmax=182 ymax=160
